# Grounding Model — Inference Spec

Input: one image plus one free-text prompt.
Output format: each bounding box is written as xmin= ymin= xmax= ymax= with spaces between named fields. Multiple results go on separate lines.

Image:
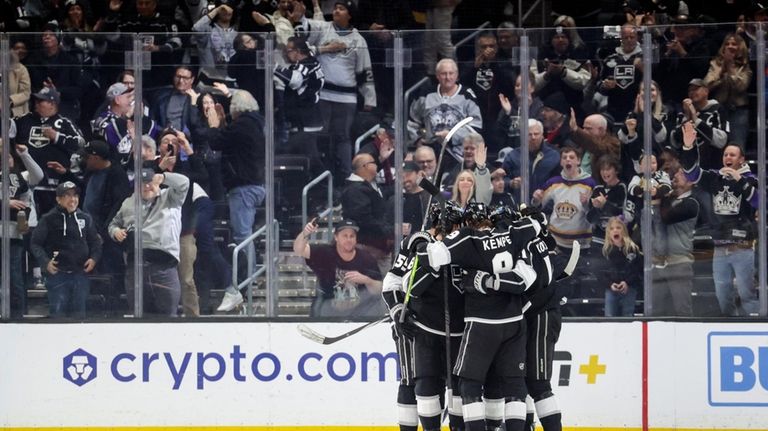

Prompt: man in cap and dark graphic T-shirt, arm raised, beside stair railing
xmin=293 ymin=219 xmax=384 ymax=317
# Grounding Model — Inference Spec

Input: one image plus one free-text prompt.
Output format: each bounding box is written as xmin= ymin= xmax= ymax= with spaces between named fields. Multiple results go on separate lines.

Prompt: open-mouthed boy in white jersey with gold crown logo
xmin=531 ymin=147 xmax=595 ymax=250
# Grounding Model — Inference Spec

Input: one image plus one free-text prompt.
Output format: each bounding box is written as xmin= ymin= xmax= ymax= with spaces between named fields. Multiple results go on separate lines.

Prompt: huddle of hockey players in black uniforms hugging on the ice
xmin=382 ymin=201 xmax=570 ymax=431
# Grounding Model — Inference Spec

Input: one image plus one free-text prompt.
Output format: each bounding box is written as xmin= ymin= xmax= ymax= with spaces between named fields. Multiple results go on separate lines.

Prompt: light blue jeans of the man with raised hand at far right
xmin=712 ymin=246 xmax=760 ymax=316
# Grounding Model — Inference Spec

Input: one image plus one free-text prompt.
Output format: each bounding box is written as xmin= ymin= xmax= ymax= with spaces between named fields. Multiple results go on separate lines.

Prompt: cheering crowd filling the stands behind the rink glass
xmin=0 ymin=0 xmax=768 ymax=317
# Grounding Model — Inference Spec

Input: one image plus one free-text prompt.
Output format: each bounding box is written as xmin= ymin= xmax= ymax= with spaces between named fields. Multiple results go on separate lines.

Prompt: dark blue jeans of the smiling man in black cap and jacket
xmin=45 ymin=272 xmax=91 ymax=319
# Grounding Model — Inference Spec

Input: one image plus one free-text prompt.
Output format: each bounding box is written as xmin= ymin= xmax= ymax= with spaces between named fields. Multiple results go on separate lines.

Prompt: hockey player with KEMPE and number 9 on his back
xmin=418 ymin=202 xmax=541 ymax=431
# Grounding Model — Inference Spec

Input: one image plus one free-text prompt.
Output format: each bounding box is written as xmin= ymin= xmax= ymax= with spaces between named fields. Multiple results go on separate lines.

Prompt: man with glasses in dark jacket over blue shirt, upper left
xmin=150 ymin=65 xmax=198 ymax=132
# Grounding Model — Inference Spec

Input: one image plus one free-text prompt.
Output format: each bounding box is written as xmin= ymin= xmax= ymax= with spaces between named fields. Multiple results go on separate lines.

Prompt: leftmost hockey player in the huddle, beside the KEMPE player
xmin=396 ymin=201 xmax=464 ymax=431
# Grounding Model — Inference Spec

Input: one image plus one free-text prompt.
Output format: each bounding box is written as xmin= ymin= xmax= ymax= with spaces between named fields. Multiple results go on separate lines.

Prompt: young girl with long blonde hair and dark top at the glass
xmin=597 ymin=217 xmax=643 ymax=317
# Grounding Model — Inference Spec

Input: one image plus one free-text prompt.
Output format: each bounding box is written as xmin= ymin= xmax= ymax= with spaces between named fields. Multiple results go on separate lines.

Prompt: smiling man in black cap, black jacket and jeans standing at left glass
xmin=30 ymin=181 xmax=102 ymax=319
